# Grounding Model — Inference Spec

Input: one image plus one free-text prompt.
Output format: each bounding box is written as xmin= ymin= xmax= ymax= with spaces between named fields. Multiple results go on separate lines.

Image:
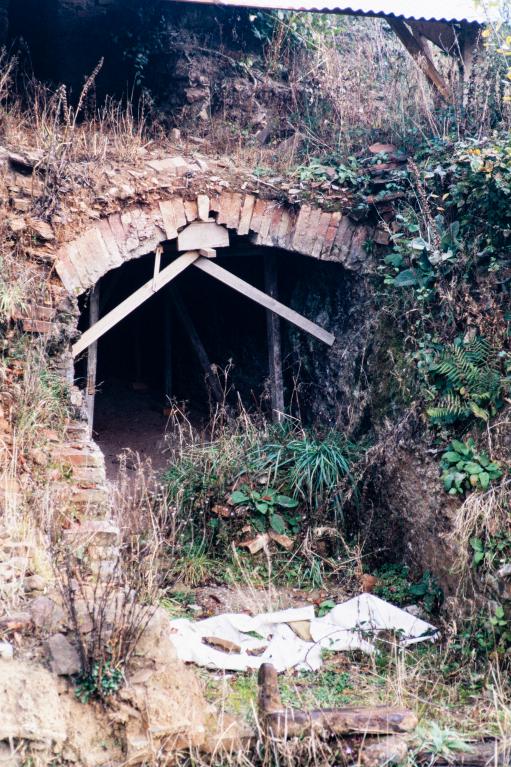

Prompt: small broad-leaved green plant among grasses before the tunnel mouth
xmin=229 ymin=485 xmax=298 ymax=534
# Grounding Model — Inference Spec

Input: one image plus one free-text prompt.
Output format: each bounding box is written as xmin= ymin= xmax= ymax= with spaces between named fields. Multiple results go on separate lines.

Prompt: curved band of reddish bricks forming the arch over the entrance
xmin=55 ymin=192 xmax=369 ymax=295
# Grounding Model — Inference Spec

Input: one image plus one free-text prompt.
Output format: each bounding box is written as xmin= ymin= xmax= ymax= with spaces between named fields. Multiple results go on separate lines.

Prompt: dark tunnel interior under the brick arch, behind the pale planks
xmin=76 ymin=237 xmax=350 ymax=476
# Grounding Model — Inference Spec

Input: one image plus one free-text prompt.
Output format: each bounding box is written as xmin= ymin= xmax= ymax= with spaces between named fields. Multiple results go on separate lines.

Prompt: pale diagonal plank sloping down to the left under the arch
xmin=72 ymin=250 xmax=200 ymax=357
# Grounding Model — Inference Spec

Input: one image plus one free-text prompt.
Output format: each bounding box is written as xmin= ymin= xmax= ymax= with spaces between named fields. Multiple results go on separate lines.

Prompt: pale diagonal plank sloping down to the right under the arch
xmin=193 ymin=256 xmax=335 ymax=346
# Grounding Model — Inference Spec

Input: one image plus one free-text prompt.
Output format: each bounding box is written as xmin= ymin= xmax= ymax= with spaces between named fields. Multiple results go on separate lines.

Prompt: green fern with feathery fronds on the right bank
xmin=426 ymin=336 xmax=508 ymax=424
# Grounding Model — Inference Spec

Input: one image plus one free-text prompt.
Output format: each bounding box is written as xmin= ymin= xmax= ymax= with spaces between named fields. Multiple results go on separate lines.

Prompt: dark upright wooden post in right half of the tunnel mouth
xmin=264 ymin=253 xmax=284 ymax=423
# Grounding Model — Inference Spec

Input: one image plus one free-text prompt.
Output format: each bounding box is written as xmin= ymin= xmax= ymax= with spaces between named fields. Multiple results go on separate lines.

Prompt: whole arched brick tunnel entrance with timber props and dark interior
xmin=56 ymin=193 xmax=372 ymax=476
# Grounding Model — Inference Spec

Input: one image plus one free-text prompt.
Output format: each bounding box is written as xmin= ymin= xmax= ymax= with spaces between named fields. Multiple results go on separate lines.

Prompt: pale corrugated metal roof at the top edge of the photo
xmin=170 ymin=0 xmax=498 ymax=24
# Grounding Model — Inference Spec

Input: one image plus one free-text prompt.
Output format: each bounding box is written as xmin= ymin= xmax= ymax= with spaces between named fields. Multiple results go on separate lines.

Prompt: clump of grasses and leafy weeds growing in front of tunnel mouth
xmin=164 ymin=412 xmax=363 ymax=575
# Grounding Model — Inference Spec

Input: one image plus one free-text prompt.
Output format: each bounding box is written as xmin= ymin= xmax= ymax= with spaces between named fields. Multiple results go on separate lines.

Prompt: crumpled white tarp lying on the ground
xmin=170 ymin=594 xmax=438 ymax=672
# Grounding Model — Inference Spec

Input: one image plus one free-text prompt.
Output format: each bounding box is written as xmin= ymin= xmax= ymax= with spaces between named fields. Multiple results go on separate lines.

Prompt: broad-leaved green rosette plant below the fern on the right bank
xmin=441 ymin=437 xmax=502 ymax=495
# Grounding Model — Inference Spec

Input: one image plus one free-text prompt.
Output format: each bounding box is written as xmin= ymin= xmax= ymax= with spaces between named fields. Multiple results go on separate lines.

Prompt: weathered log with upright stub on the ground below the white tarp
xmin=259 ymin=663 xmax=417 ymax=738
